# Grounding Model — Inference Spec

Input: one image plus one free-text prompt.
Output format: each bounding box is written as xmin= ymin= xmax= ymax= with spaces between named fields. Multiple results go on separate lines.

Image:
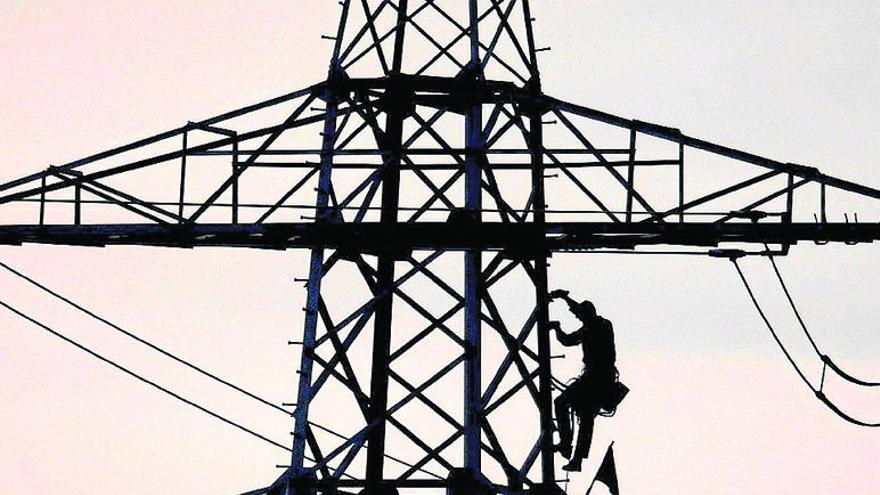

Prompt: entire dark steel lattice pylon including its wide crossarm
xmin=0 ymin=0 xmax=880 ymax=495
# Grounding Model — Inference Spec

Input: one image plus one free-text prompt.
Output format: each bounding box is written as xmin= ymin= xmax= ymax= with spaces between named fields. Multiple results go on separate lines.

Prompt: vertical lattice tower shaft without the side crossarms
xmin=289 ymin=0 xmax=555 ymax=493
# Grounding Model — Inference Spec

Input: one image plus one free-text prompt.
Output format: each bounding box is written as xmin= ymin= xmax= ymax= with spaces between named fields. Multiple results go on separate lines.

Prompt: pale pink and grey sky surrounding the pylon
xmin=0 ymin=0 xmax=880 ymax=494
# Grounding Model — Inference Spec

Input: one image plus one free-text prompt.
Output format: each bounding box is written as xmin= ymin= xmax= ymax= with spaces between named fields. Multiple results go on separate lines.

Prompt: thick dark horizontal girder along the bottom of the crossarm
xmin=0 ymin=222 xmax=880 ymax=257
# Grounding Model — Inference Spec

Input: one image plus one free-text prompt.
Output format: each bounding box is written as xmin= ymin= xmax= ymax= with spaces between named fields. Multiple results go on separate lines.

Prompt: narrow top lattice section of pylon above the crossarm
xmin=328 ymin=0 xmax=539 ymax=85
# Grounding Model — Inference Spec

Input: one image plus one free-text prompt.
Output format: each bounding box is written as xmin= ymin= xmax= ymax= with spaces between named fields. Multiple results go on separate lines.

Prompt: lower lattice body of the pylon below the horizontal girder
xmin=270 ymin=250 xmax=560 ymax=493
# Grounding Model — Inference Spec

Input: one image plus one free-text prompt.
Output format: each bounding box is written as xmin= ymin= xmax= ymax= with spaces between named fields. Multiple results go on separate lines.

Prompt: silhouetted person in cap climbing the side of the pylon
xmin=549 ymin=290 xmax=626 ymax=471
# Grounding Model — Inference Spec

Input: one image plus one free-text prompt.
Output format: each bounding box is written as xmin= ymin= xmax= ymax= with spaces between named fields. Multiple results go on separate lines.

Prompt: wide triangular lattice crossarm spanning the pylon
xmin=0 ymin=75 xmax=880 ymax=249
